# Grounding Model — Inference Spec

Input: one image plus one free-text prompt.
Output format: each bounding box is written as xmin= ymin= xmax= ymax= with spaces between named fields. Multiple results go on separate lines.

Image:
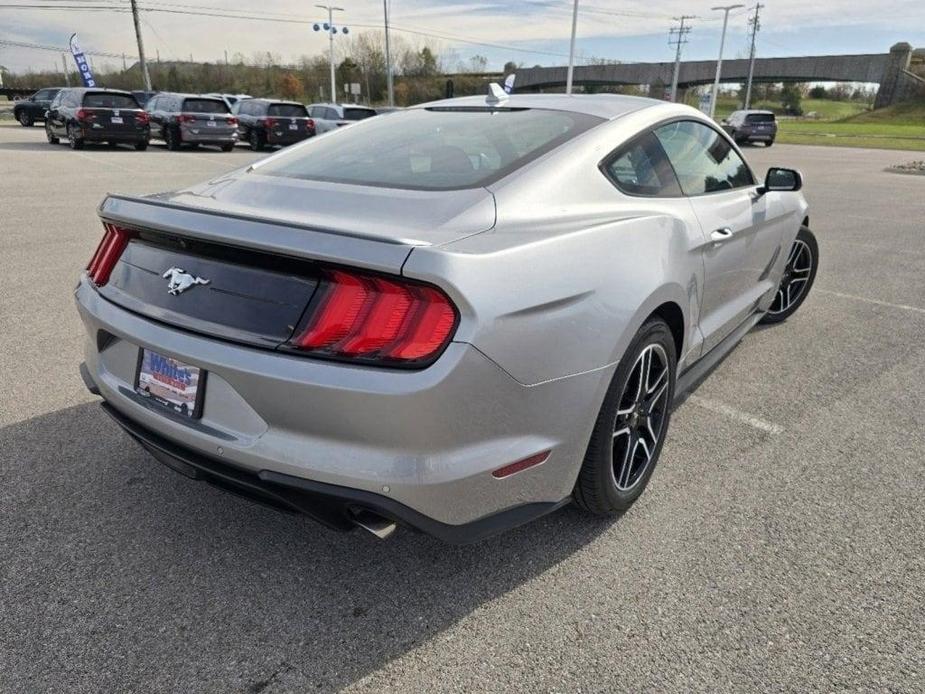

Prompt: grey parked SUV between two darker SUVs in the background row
xmin=145 ymin=92 xmax=238 ymax=152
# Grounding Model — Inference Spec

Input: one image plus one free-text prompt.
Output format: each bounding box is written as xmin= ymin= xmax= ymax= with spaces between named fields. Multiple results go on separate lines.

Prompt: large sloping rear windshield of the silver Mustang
xmin=258 ymin=109 xmax=603 ymax=190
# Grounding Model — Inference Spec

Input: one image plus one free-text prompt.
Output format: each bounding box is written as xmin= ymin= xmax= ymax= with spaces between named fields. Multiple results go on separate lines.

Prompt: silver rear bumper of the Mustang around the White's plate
xmin=76 ymin=279 xmax=612 ymax=541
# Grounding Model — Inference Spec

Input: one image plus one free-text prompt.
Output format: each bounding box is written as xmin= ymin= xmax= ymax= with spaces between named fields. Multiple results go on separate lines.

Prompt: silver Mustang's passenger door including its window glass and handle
xmin=655 ymin=120 xmax=787 ymax=352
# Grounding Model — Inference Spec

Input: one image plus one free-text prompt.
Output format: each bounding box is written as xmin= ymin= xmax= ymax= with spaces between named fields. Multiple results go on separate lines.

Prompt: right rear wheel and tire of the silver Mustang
xmin=573 ymin=318 xmax=677 ymax=515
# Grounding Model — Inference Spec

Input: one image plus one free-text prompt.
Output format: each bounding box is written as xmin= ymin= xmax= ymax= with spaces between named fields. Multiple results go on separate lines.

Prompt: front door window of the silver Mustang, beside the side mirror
xmin=655 ymin=121 xmax=755 ymax=195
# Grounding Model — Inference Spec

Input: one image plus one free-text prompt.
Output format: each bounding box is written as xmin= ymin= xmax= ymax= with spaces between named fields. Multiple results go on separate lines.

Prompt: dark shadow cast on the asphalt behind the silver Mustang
xmin=0 ymin=403 xmax=613 ymax=692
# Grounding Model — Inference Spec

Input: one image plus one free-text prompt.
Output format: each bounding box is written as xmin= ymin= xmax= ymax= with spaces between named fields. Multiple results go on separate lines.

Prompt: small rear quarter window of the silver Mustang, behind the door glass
xmin=604 ymin=133 xmax=681 ymax=198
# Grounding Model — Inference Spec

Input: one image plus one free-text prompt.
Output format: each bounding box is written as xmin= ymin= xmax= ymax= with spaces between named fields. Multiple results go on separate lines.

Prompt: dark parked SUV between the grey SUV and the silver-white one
xmin=232 ymin=99 xmax=315 ymax=152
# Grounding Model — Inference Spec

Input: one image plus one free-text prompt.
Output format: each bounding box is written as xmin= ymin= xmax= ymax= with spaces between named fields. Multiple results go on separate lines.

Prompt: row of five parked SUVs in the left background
xmin=13 ymin=87 xmax=379 ymax=152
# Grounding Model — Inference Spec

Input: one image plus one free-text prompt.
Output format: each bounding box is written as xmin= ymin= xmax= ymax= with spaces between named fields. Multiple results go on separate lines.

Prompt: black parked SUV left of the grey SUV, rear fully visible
xmin=45 ymin=87 xmax=149 ymax=150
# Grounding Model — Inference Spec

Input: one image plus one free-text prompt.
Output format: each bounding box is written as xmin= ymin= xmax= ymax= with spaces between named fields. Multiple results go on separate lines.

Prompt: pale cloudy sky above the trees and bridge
xmin=0 ymin=0 xmax=925 ymax=72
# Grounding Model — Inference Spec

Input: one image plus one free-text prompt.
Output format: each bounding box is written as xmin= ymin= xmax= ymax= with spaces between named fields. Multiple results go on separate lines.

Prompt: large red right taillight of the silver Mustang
xmin=291 ymin=270 xmax=456 ymax=366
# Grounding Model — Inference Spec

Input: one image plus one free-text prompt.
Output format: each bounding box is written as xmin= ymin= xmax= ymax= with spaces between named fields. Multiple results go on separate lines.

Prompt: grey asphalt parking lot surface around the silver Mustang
xmin=0 ymin=127 xmax=925 ymax=693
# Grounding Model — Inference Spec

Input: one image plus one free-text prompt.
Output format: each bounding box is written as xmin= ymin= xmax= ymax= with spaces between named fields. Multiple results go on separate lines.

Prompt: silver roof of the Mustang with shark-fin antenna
xmin=411 ymin=94 xmax=666 ymax=120
